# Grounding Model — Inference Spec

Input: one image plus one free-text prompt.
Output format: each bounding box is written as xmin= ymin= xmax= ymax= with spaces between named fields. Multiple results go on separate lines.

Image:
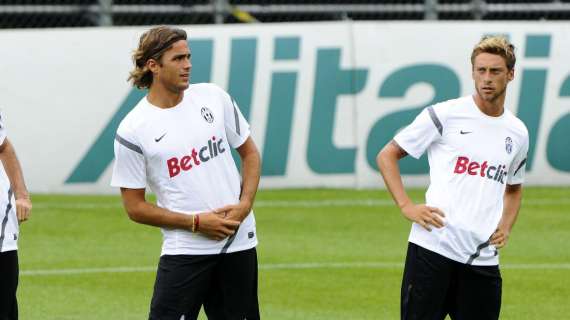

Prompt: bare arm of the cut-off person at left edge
xmin=0 ymin=138 xmax=32 ymax=223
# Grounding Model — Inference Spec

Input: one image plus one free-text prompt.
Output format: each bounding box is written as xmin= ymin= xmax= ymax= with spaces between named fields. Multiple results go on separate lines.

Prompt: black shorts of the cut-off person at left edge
xmin=0 ymin=250 xmax=19 ymax=320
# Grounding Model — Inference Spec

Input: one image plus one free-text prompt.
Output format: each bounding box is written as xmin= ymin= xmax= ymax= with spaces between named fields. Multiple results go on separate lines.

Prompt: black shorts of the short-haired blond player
xmin=401 ymin=243 xmax=496 ymax=320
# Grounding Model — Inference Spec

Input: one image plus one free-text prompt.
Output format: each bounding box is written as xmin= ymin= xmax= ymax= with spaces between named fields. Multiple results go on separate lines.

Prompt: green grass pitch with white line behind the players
xmin=18 ymin=188 xmax=570 ymax=320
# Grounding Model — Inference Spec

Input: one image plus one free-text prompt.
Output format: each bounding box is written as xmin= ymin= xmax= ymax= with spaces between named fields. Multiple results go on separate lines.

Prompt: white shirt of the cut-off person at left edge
xmin=0 ymin=111 xmax=19 ymax=252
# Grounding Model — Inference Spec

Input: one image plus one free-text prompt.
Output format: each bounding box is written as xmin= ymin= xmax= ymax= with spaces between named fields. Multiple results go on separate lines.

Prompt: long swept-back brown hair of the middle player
xmin=127 ymin=26 xmax=187 ymax=89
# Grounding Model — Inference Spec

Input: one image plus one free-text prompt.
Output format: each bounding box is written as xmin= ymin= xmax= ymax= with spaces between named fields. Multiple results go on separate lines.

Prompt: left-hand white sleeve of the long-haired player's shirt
xmin=111 ymin=127 xmax=146 ymax=189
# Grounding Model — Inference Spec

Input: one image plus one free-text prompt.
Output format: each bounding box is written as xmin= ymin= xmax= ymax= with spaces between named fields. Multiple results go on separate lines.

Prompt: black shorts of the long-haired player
xmin=149 ymin=248 xmax=260 ymax=320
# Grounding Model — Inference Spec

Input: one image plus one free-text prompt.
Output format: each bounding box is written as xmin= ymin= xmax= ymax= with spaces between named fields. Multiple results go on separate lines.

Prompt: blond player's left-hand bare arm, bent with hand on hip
xmin=376 ymin=140 xmax=444 ymax=231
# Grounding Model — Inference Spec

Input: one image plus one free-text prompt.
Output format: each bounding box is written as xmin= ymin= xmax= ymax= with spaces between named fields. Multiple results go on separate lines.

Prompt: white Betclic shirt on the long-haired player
xmin=111 ymin=83 xmax=257 ymax=255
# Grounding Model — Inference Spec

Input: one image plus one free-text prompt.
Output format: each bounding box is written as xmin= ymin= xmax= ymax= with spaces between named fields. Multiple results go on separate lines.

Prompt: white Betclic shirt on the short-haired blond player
xmin=394 ymin=96 xmax=528 ymax=265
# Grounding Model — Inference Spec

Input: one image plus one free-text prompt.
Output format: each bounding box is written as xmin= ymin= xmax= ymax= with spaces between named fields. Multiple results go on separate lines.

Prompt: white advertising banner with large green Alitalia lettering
xmin=0 ymin=22 xmax=570 ymax=193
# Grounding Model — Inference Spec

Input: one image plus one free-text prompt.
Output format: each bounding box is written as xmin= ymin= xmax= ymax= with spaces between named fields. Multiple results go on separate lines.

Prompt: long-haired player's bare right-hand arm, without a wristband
xmin=219 ymin=137 xmax=261 ymax=222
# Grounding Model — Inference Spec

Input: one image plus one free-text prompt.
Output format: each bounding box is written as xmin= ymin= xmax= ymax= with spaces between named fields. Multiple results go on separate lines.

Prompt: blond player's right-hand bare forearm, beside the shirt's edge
xmin=490 ymin=184 xmax=522 ymax=249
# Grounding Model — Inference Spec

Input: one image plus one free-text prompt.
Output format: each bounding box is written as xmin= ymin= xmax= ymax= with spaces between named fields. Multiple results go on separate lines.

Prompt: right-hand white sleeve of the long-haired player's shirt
xmin=223 ymin=94 xmax=250 ymax=149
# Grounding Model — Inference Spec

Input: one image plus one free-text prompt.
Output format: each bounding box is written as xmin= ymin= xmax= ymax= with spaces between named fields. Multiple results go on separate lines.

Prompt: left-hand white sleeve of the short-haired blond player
xmin=394 ymin=107 xmax=443 ymax=159
